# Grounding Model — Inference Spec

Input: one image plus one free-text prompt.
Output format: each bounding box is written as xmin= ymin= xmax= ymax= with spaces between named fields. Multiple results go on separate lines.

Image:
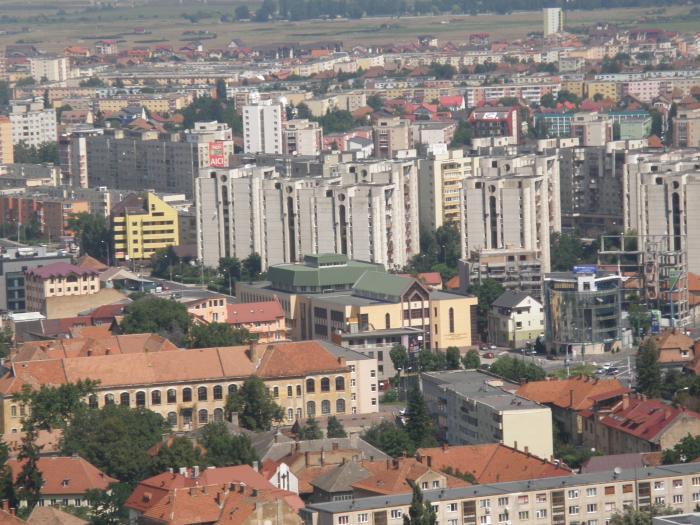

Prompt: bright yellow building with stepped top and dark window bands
xmin=112 ymin=193 xmax=179 ymax=261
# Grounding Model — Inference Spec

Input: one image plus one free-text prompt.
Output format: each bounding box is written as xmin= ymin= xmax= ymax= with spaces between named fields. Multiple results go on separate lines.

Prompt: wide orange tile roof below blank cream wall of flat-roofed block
xmin=416 ymin=443 xmax=571 ymax=485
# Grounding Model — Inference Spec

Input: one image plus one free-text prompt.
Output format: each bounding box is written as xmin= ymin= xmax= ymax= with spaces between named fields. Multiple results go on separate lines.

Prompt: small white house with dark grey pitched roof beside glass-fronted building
xmin=488 ymin=290 xmax=544 ymax=348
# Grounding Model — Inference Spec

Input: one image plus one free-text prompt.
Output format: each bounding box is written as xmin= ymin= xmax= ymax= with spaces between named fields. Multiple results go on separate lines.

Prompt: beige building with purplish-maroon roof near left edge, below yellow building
xmin=25 ymin=262 xmax=100 ymax=312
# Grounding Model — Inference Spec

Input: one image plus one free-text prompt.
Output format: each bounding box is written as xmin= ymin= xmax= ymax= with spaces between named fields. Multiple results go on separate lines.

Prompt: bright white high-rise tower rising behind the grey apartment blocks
xmin=243 ymin=100 xmax=285 ymax=153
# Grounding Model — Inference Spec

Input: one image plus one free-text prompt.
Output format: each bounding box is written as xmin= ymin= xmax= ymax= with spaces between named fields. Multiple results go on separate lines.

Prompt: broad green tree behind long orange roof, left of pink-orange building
xmin=121 ymin=297 xmax=191 ymax=344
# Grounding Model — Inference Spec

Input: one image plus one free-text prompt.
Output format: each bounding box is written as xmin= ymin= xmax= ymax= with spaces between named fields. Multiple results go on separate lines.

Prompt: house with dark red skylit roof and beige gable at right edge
xmin=581 ymin=395 xmax=700 ymax=454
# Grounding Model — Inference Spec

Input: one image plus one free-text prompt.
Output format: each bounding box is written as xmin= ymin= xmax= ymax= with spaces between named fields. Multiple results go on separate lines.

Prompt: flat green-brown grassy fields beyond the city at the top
xmin=0 ymin=0 xmax=700 ymax=51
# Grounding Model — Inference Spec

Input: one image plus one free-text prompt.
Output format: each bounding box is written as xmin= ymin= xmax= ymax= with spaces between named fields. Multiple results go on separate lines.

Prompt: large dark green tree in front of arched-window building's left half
xmin=61 ymin=403 xmax=167 ymax=484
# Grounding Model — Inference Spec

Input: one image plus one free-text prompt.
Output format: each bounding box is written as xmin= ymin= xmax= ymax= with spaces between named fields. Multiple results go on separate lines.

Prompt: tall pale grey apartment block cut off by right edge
xmin=623 ymin=150 xmax=700 ymax=273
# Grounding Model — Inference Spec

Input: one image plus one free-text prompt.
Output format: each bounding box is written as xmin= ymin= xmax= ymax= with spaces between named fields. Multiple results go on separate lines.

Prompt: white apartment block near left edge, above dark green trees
xmin=10 ymin=100 xmax=58 ymax=147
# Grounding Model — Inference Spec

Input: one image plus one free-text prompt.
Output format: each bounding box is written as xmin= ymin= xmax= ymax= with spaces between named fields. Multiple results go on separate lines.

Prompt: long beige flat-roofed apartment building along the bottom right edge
xmin=301 ymin=463 xmax=700 ymax=525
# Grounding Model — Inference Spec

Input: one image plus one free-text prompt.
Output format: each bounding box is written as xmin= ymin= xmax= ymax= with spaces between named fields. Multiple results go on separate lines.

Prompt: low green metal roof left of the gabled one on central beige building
xmin=267 ymin=255 xmax=385 ymax=291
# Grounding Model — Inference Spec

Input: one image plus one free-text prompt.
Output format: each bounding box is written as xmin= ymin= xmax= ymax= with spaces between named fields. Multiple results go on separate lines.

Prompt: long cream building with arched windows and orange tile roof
xmin=0 ymin=341 xmax=379 ymax=433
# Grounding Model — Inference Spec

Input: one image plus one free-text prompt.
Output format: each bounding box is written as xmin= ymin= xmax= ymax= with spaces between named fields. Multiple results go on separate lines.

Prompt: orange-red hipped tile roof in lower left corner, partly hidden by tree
xmin=7 ymin=456 xmax=118 ymax=495
